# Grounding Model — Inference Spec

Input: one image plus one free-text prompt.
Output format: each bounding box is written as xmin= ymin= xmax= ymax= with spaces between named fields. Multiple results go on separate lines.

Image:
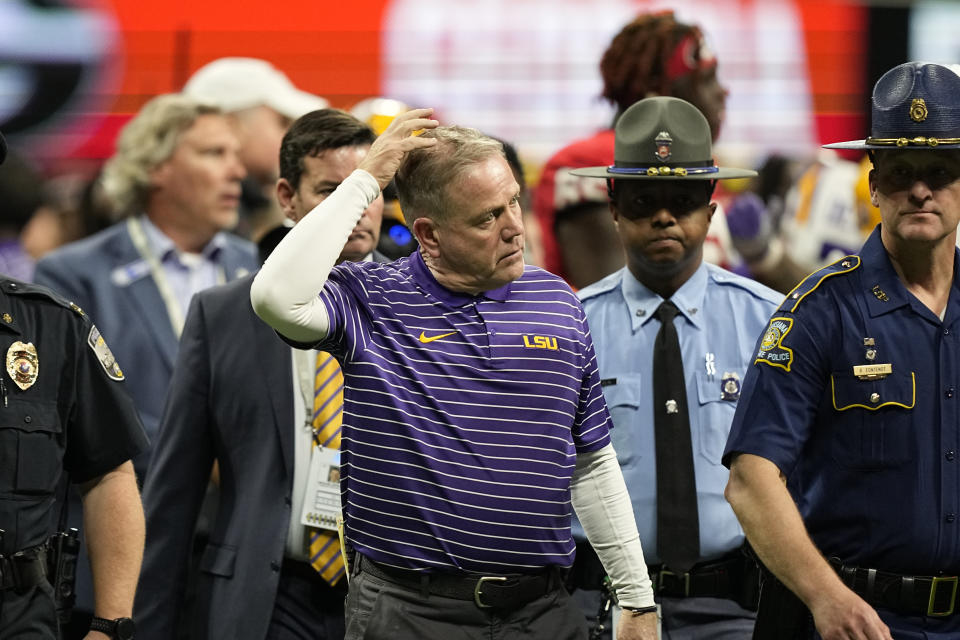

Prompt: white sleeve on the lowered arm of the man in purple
xmin=570 ymin=445 xmax=654 ymax=607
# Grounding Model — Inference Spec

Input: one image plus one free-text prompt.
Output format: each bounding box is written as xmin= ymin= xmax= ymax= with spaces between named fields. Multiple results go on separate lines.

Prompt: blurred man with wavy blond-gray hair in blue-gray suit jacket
xmin=35 ymin=95 xmax=257 ymax=637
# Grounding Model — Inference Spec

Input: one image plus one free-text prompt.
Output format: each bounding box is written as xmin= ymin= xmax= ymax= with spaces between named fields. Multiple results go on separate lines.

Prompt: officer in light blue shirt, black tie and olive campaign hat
xmin=573 ymin=97 xmax=783 ymax=640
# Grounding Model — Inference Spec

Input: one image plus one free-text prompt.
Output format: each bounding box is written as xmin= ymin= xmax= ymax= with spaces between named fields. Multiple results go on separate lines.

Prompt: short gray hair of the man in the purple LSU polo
xmin=396 ymin=126 xmax=506 ymax=223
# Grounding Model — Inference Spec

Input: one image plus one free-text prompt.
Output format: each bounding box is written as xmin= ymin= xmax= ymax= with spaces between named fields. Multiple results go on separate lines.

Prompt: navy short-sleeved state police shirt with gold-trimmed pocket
xmin=724 ymin=227 xmax=960 ymax=575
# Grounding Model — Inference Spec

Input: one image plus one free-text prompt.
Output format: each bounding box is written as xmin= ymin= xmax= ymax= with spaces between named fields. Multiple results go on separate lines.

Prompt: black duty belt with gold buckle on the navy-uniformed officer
xmin=830 ymin=558 xmax=960 ymax=617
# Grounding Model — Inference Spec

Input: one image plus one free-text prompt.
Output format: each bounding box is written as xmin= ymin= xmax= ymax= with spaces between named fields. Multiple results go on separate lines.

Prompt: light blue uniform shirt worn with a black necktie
xmin=577 ymin=263 xmax=783 ymax=564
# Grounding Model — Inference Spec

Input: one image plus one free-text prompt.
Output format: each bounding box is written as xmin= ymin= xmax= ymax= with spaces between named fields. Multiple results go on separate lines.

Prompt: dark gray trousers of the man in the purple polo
xmin=346 ymin=572 xmax=587 ymax=640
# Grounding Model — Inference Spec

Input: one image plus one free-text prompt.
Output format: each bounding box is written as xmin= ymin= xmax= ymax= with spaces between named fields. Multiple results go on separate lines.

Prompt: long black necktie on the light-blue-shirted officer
xmin=653 ymin=300 xmax=700 ymax=572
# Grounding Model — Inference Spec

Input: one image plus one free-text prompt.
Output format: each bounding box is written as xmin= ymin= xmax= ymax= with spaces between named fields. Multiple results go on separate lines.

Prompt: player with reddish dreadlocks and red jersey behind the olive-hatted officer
xmin=533 ymin=11 xmax=732 ymax=288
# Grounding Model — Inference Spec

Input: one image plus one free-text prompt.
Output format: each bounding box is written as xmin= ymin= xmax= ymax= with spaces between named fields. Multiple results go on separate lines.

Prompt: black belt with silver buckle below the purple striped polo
xmin=355 ymin=553 xmax=563 ymax=609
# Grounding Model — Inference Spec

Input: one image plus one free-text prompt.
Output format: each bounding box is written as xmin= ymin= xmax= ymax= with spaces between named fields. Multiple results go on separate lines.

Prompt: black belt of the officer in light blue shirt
xmin=648 ymin=551 xmax=746 ymax=600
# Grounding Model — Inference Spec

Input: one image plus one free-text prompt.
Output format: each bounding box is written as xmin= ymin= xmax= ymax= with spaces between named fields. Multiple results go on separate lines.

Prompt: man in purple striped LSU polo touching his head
xmin=251 ymin=109 xmax=656 ymax=640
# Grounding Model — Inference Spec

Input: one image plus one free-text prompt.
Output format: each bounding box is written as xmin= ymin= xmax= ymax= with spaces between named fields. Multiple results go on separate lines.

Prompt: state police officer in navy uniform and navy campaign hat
xmin=724 ymin=63 xmax=960 ymax=640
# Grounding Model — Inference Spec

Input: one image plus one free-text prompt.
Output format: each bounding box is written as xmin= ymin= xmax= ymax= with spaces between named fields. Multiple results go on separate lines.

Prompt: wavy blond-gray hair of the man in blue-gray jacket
xmin=100 ymin=93 xmax=221 ymax=215
